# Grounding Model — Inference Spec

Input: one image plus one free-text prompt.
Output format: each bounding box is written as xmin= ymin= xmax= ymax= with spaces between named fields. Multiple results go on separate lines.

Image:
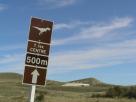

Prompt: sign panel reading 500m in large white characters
xmin=25 ymin=53 xmax=48 ymax=68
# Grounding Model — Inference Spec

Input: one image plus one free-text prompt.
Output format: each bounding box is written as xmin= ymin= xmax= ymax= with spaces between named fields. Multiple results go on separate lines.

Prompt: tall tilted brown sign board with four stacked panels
xmin=23 ymin=18 xmax=53 ymax=85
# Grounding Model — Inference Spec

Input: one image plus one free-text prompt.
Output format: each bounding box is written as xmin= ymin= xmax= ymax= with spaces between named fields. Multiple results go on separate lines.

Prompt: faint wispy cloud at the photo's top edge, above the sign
xmin=38 ymin=0 xmax=77 ymax=8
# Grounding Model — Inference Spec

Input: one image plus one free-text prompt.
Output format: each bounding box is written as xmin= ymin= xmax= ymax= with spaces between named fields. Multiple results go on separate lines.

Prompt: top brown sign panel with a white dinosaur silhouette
xmin=29 ymin=18 xmax=53 ymax=44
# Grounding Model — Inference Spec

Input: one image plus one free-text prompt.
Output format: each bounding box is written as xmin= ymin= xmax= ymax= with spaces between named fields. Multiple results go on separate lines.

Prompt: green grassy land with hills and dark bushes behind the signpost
xmin=0 ymin=73 xmax=136 ymax=102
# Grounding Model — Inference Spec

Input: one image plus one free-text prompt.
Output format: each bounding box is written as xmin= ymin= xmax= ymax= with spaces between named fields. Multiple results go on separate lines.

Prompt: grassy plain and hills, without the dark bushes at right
xmin=0 ymin=73 xmax=136 ymax=102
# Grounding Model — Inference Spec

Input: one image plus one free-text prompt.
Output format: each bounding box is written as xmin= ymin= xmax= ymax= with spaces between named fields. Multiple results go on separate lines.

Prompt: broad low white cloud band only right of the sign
xmin=50 ymin=40 xmax=136 ymax=70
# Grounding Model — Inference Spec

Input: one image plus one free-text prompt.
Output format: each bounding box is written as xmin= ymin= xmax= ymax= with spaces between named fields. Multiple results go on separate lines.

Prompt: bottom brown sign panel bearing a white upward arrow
xmin=23 ymin=66 xmax=47 ymax=85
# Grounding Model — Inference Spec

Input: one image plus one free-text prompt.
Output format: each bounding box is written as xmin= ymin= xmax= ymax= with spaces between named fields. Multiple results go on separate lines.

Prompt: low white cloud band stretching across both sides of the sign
xmin=0 ymin=39 xmax=136 ymax=73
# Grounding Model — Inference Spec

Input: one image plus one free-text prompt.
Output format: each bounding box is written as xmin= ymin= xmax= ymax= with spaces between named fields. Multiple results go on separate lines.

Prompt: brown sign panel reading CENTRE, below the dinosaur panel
xmin=27 ymin=41 xmax=50 ymax=56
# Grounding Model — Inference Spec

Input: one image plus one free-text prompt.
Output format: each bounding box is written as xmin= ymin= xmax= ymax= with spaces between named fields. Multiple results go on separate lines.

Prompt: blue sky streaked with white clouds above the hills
xmin=0 ymin=0 xmax=136 ymax=85
